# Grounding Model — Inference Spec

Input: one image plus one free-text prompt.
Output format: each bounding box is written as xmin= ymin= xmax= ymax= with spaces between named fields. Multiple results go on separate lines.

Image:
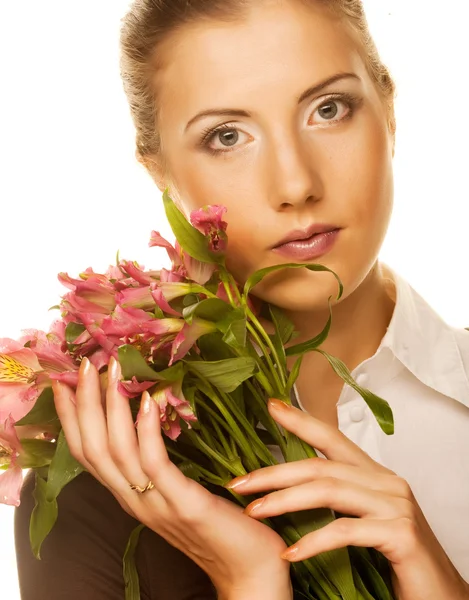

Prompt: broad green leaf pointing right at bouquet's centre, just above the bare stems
xmin=186 ymin=356 xmax=257 ymax=393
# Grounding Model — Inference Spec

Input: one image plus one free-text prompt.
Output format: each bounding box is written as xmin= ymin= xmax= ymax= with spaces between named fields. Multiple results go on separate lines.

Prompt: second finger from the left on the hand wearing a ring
xmin=76 ymin=358 xmax=135 ymax=503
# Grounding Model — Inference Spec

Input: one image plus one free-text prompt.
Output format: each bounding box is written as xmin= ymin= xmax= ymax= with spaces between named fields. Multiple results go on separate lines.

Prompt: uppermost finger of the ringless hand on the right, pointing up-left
xmin=268 ymin=399 xmax=391 ymax=473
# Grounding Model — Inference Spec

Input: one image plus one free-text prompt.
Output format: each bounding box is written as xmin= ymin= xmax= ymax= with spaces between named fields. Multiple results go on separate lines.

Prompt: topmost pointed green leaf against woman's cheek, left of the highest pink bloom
xmin=163 ymin=188 xmax=222 ymax=264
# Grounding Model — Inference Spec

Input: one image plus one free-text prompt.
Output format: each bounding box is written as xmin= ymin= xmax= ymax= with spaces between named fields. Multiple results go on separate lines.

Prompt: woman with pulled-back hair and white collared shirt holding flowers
xmin=16 ymin=0 xmax=469 ymax=600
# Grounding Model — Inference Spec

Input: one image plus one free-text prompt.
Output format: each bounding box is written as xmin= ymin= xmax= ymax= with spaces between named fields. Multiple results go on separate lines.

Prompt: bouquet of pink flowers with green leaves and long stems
xmin=0 ymin=191 xmax=394 ymax=600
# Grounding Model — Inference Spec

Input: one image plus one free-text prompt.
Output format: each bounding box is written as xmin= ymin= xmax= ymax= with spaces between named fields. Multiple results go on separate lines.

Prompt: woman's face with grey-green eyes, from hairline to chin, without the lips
xmin=156 ymin=1 xmax=393 ymax=311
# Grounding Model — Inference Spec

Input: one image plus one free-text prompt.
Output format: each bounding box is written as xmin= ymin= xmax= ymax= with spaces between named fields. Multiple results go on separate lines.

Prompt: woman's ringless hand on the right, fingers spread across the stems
xmin=225 ymin=400 xmax=469 ymax=600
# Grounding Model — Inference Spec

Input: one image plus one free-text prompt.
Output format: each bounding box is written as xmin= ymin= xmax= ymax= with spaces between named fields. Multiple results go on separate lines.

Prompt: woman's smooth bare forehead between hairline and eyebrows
xmin=155 ymin=1 xmax=365 ymax=124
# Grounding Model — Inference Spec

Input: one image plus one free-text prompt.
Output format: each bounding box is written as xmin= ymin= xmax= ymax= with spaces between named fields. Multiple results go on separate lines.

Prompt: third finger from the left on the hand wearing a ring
xmin=106 ymin=358 xmax=154 ymax=487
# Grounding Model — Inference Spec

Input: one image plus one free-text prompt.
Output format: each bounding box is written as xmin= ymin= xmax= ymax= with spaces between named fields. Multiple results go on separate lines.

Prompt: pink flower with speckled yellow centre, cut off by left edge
xmin=0 ymin=338 xmax=49 ymax=422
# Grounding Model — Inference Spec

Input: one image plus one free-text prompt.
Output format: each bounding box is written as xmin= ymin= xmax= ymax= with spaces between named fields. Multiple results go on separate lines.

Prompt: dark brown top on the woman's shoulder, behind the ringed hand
xmin=15 ymin=471 xmax=217 ymax=600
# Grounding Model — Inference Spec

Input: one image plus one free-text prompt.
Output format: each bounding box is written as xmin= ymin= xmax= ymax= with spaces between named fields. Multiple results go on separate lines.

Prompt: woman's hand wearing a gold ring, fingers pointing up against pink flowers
xmin=54 ymin=359 xmax=291 ymax=600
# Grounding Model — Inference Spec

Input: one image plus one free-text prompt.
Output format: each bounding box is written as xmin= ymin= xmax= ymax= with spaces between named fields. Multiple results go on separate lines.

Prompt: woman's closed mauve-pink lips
xmin=272 ymin=225 xmax=341 ymax=262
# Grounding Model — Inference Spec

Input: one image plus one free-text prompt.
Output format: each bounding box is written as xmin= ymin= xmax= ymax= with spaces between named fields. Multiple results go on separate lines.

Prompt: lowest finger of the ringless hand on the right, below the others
xmin=281 ymin=518 xmax=415 ymax=564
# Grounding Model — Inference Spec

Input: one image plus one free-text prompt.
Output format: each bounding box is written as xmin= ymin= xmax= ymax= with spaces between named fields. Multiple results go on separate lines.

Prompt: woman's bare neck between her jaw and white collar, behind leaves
xmin=287 ymin=262 xmax=395 ymax=424
